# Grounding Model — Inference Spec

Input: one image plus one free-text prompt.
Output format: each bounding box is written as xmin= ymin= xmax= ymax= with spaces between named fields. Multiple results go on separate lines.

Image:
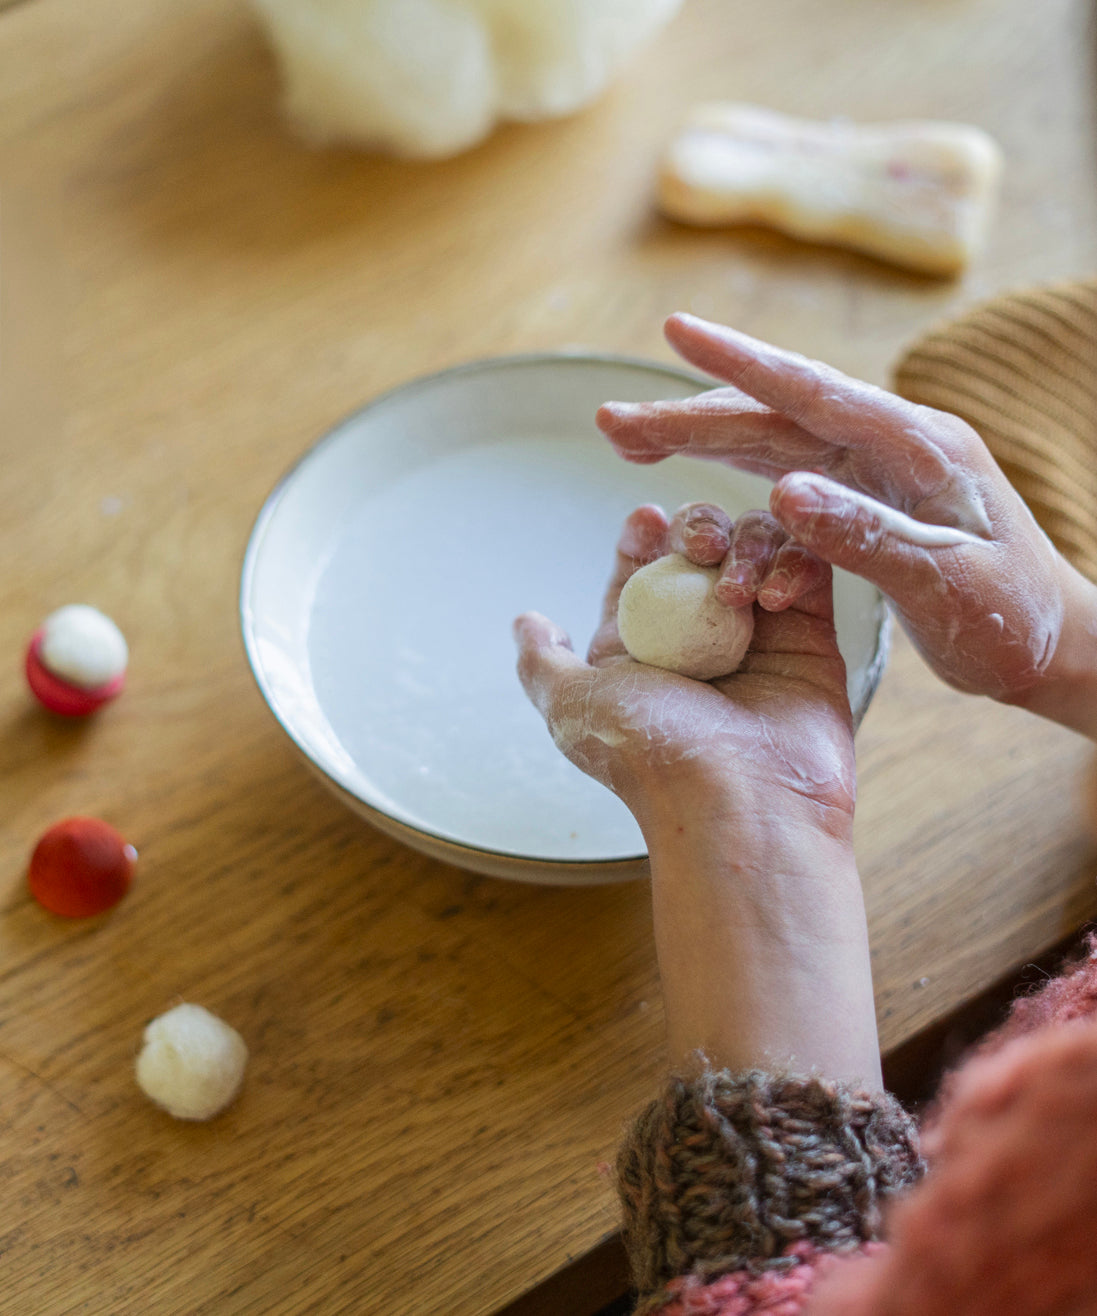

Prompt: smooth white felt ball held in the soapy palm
xmin=617 ymin=553 xmax=754 ymax=680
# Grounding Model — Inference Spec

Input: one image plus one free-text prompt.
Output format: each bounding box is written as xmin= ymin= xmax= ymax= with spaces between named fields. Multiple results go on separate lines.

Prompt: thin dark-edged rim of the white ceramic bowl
xmin=237 ymin=347 xmax=889 ymax=884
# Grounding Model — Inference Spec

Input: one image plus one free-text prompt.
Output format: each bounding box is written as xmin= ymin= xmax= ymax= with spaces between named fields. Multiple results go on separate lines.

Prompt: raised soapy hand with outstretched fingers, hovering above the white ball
xmin=598 ymin=315 xmax=1072 ymax=703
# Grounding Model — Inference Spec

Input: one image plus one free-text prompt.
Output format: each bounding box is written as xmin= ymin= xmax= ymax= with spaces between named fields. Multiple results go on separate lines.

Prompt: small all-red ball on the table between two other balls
xmin=26 ymin=817 xmax=137 ymax=919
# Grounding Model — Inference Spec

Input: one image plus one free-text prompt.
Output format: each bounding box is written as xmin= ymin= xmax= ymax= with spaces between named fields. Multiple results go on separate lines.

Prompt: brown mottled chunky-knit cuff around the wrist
xmin=617 ymin=1069 xmax=922 ymax=1295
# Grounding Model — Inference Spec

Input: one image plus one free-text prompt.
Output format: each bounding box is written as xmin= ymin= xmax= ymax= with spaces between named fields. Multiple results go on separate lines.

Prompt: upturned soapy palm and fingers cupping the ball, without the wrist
xmin=514 ymin=507 xmax=854 ymax=828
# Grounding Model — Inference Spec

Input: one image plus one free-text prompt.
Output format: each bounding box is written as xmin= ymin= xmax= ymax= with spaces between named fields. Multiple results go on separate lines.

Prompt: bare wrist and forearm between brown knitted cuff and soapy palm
xmin=645 ymin=779 xmax=881 ymax=1088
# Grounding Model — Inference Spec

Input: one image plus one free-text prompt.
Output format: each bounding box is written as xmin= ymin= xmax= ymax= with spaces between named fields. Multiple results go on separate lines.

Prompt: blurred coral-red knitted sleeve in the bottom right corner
xmin=805 ymin=1021 xmax=1097 ymax=1316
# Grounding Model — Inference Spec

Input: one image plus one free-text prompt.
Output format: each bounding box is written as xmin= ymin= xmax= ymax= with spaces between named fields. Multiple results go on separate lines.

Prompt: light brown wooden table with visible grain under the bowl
xmin=0 ymin=0 xmax=1097 ymax=1316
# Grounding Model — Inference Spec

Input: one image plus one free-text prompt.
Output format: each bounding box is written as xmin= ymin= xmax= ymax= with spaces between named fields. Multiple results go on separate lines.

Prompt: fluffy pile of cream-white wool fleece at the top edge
xmin=253 ymin=0 xmax=681 ymax=158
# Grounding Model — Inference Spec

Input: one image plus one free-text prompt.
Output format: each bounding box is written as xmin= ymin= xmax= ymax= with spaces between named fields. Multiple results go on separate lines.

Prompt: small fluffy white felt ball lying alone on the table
xmin=137 ymin=1004 xmax=247 ymax=1120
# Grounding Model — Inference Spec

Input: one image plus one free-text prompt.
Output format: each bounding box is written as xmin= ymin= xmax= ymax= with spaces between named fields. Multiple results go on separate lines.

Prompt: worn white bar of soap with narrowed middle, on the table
xmin=659 ymin=103 xmax=1002 ymax=275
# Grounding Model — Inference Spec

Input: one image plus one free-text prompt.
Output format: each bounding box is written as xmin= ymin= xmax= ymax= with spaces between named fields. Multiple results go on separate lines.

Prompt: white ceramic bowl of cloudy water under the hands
xmin=241 ymin=353 xmax=887 ymax=883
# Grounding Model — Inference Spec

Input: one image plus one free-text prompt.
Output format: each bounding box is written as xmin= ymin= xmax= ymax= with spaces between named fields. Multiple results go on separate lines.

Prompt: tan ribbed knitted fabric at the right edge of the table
xmin=894 ymin=279 xmax=1097 ymax=580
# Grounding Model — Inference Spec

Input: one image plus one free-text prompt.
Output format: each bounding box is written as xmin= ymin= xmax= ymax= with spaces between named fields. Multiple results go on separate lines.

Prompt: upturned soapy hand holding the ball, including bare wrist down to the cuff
xmin=516 ymin=507 xmax=880 ymax=1087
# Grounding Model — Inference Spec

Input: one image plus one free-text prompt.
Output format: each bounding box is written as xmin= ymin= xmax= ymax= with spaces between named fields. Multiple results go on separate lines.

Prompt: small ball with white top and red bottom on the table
xmin=25 ymin=603 xmax=129 ymax=717
